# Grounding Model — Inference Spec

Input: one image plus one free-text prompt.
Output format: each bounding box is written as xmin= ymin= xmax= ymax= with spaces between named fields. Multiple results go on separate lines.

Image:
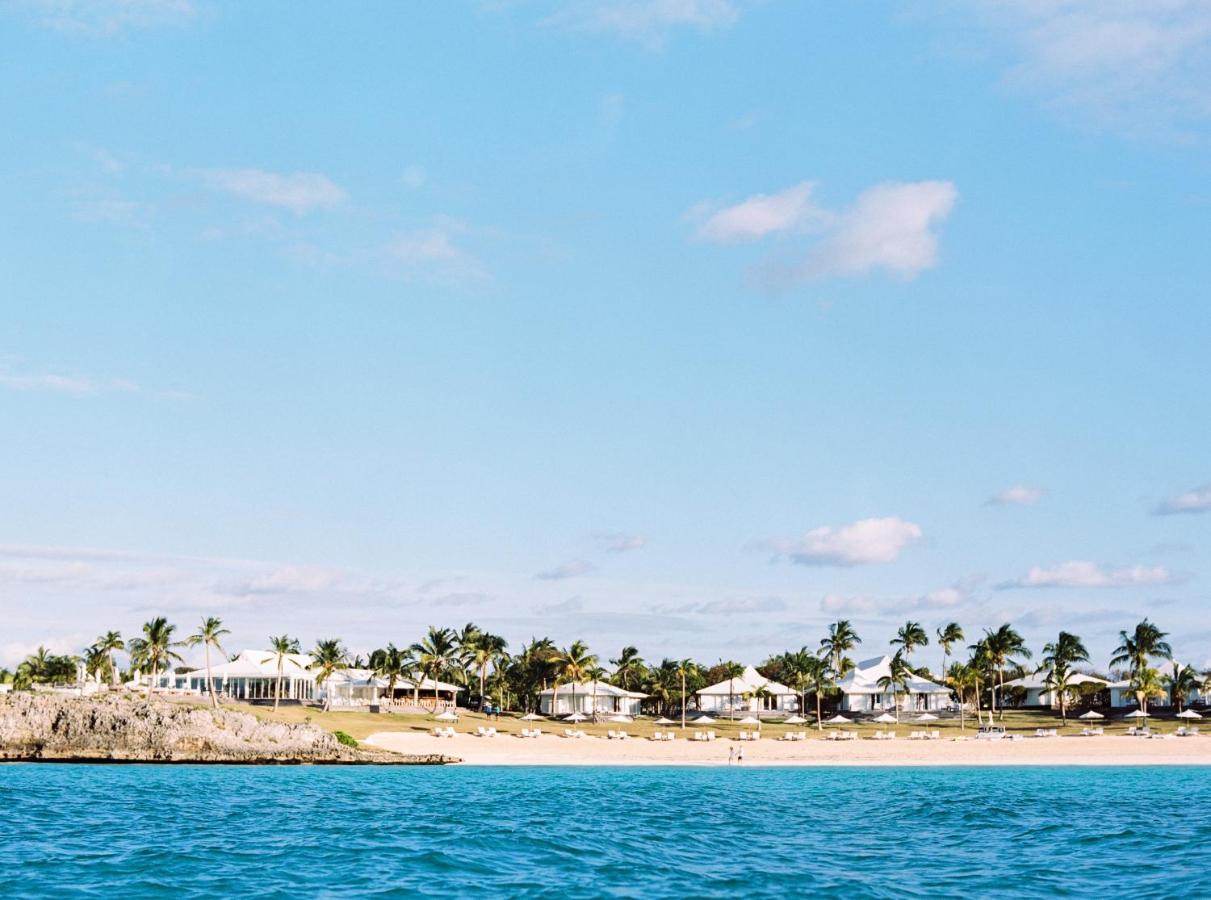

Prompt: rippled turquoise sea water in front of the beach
xmin=0 ymin=764 xmax=1211 ymax=900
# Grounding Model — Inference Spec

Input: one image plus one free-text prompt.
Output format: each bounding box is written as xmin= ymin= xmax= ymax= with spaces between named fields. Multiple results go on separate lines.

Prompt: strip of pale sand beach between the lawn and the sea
xmin=366 ymin=732 xmax=1211 ymax=766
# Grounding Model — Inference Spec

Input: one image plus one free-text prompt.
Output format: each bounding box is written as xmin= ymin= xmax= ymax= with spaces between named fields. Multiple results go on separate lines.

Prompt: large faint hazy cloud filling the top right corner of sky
xmin=968 ymin=0 xmax=1211 ymax=137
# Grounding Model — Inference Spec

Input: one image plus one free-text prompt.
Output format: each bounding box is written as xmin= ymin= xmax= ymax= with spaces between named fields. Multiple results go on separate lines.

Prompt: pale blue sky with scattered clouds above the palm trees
xmin=0 ymin=0 xmax=1211 ymax=669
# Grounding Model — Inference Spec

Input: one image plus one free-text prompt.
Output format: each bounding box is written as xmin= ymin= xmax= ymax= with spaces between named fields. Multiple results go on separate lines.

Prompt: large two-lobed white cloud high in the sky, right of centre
xmin=688 ymin=180 xmax=958 ymax=288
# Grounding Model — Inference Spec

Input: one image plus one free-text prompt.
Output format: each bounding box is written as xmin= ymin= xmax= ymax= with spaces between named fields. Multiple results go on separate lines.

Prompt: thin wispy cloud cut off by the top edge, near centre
xmin=546 ymin=0 xmax=740 ymax=47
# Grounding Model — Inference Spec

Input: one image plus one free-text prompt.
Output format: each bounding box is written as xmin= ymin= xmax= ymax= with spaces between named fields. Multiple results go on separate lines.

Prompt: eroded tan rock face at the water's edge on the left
xmin=0 ymin=693 xmax=452 ymax=763
